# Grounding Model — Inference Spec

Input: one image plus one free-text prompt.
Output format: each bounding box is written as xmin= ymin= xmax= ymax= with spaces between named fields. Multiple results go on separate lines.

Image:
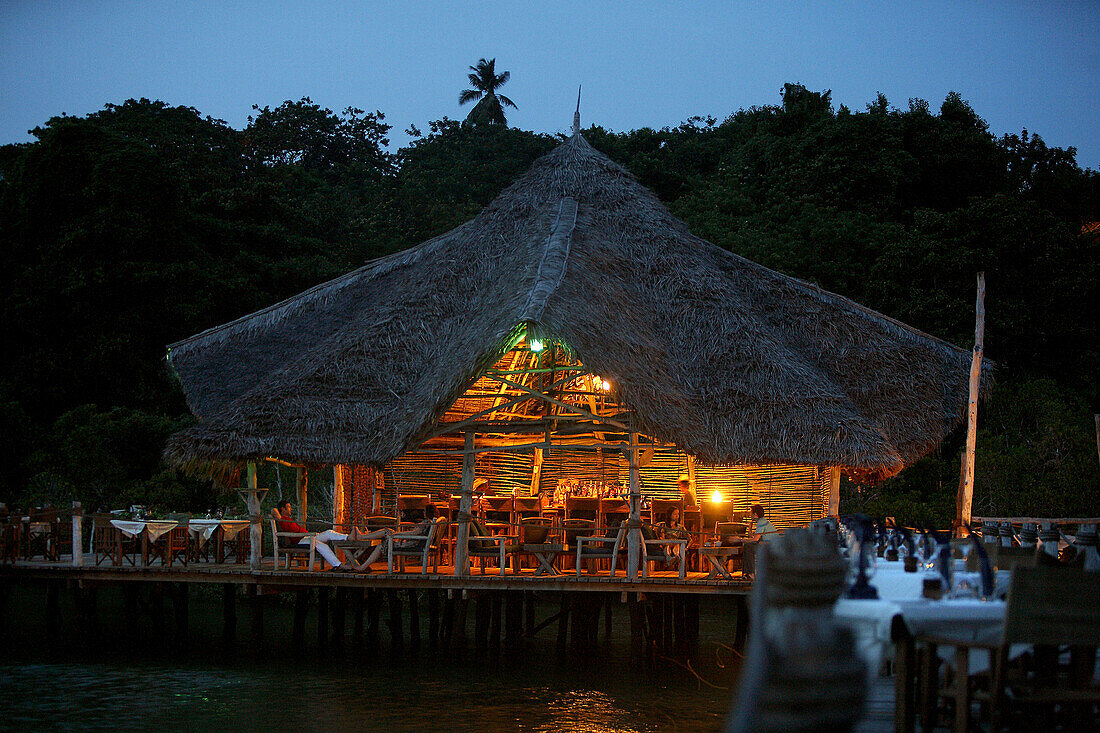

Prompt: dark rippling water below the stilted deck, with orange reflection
xmin=0 ymin=589 xmax=736 ymax=732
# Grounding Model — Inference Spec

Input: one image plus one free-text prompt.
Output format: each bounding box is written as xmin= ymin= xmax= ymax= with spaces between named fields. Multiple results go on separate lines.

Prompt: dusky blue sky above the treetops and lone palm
xmin=0 ymin=0 xmax=1100 ymax=168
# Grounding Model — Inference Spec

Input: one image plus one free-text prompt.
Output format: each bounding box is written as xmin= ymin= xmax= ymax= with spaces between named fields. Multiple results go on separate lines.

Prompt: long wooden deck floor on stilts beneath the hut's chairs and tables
xmin=0 ymin=555 xmax=752 ymax=595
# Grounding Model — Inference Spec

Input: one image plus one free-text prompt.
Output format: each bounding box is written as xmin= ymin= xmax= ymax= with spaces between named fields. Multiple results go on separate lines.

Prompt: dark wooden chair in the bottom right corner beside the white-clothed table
xmin=917 ymin=566 xmax=1100 ymax=731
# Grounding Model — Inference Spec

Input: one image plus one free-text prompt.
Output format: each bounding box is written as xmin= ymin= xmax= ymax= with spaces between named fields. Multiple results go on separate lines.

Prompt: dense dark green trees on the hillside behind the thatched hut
xmin=0 ymin=85 xmax=1100 ymax=524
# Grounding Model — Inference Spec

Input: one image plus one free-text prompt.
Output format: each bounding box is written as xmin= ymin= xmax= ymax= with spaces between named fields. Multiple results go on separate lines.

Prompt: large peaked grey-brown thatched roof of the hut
xmin=166 ymin=129 xmax=970 ymax=474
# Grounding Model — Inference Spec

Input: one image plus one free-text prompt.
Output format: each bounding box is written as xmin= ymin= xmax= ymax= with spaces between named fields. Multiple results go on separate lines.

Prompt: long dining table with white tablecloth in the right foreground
xmin=833 ymin=559 xmax=1010 ymax=731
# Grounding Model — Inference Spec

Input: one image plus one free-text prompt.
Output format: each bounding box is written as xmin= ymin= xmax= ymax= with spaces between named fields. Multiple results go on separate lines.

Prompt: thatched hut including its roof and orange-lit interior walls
xmin=166 ymin=128 xmax=970 ymax=572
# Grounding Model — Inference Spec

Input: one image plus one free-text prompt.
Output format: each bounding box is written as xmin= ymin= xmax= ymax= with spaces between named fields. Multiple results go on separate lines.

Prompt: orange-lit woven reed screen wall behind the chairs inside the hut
xmin=374 ymin=447 xmax=829 ymax=528
